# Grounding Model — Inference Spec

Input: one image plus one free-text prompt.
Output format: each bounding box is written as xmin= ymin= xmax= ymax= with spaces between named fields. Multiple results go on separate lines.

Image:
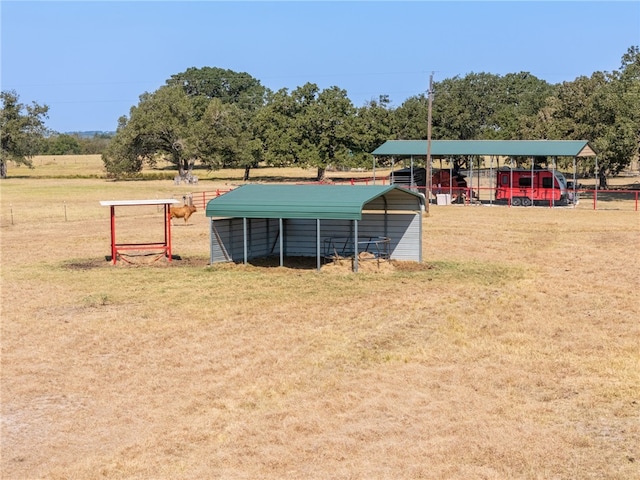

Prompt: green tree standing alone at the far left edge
xmin=0 ymin=90 xmax=49 ymax=178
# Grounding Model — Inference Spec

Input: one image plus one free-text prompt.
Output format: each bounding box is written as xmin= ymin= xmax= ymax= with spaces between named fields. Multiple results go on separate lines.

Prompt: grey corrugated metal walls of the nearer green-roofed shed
xmin=211 ymin=191 xmax=422 ymax=263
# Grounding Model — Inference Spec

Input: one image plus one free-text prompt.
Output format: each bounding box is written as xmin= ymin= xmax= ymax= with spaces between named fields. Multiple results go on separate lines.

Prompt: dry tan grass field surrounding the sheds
xmin=0 ymin=158 xmax=640 ymax=480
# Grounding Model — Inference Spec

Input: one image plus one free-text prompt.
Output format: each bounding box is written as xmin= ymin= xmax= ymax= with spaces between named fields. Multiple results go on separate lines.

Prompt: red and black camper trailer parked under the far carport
xmin=496 ymin=168 xmax=573 ymax=207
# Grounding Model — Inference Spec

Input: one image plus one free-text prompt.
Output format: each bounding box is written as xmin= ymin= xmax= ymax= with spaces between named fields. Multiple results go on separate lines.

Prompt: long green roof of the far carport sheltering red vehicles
xmin=372 ymin=140 xmax=596 ymax=157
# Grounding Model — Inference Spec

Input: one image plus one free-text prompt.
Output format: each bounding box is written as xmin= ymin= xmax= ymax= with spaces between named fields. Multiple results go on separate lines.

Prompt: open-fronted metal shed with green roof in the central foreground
xmin=205 ymin=184 xmax=425 ymax=271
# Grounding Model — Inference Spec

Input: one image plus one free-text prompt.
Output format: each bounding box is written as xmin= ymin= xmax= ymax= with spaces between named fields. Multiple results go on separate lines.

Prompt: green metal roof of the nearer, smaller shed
xmin=206 ymin=184 xmax=423 ymax=220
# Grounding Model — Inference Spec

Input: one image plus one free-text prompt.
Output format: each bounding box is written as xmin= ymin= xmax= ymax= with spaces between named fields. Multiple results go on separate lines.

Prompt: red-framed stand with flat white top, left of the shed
xmin=100 ymin=198 xmax=179 ymax=265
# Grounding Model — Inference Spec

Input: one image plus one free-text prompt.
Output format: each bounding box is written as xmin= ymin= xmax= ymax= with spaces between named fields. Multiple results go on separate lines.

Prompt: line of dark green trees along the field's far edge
xmin=0 ymin=46 xmax=640 ymax=180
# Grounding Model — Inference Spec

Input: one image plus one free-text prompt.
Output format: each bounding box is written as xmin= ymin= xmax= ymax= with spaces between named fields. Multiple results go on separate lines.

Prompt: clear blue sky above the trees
xmin=0 ymin=0 xmax=640 ymax=132
